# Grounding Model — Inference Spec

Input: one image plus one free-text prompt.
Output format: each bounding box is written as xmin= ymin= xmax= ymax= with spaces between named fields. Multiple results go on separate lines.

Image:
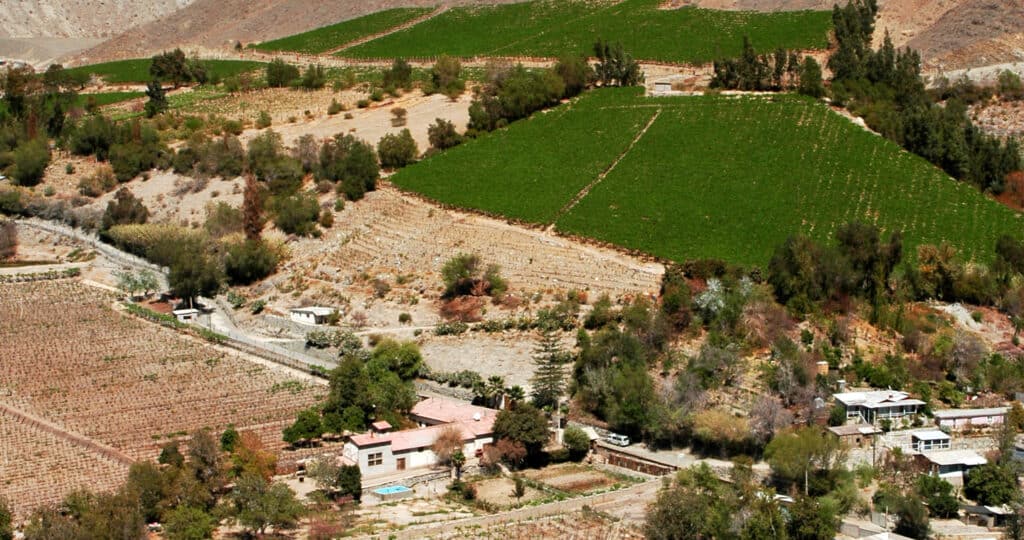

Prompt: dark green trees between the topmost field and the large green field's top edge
xmin=711 ymin=37 xmax=825 ymax=97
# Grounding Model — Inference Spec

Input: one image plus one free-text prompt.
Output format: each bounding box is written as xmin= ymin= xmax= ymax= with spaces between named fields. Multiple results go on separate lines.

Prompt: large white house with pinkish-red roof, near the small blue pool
xmin=342 ymin=398 xmax=498 ymax=477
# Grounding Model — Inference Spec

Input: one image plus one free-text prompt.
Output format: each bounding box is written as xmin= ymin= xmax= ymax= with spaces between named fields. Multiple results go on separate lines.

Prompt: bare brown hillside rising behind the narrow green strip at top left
xmin=71 ymin=0 xmax=516 ymax=63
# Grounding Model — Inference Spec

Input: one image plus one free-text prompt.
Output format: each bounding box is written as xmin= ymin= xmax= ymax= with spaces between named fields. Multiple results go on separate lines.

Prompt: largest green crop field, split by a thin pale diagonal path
xmin=392 ymin=89 xmax=1021 ymax=265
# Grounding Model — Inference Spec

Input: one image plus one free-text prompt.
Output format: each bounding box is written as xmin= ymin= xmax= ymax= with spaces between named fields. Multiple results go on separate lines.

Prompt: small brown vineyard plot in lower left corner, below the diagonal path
xmin=0 ymin=409 xmax=128 ymax=517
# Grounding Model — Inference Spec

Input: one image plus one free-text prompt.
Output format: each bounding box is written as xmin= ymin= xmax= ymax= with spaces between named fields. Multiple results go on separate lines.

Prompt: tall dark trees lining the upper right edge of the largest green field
xmin=828 ymin=0 xmax=1021 ymax=194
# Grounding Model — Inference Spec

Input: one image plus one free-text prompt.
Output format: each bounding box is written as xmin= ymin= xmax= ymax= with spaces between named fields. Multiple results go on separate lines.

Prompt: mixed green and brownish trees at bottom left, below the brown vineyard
xmin=9 ymin=427 xmax=304 ymax=540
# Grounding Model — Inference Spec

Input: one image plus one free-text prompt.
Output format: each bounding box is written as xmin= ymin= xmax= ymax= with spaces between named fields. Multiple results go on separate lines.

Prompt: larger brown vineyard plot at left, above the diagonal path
xmin=0 ymin=280 xmax=325 ymax=459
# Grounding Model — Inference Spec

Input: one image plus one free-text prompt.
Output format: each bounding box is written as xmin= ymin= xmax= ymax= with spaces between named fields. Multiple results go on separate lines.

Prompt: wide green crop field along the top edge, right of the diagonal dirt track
xmin=338 ymin=0 xmax=831 ymax=61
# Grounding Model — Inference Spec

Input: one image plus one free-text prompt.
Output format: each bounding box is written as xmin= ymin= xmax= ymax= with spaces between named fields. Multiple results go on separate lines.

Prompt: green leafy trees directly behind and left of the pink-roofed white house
xmin=284 ymin=339 xmax=423 ymax=445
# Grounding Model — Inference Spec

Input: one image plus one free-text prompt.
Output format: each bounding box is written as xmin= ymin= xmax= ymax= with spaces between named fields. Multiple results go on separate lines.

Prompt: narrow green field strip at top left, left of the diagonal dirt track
xmin=252 ymin=8 xmax=431 ymax=54
